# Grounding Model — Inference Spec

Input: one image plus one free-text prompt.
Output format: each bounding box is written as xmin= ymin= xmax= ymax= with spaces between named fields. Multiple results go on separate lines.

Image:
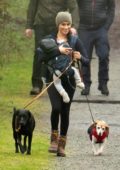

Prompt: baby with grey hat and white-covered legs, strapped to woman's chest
xmin=37 ymin=38 xmax=84 ymax=103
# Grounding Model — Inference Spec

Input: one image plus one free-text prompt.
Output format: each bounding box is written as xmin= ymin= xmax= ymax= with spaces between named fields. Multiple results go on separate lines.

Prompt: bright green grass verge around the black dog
xmin=0 ymin=54 xmax=53 ymax=170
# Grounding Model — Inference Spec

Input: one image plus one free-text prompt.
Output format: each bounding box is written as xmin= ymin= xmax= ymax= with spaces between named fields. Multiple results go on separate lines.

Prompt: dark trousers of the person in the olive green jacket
xmin=32 ymin=25 xmax=55 ymax=89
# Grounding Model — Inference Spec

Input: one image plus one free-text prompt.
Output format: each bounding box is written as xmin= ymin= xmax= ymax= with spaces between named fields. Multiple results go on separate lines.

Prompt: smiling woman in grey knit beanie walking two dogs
xmin=41 ymin=11 xmax=89 ymax=157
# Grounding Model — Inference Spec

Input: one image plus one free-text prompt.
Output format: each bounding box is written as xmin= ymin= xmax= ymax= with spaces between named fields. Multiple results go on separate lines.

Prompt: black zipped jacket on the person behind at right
xmin=77 ymin=0 xmax=115 ymax=30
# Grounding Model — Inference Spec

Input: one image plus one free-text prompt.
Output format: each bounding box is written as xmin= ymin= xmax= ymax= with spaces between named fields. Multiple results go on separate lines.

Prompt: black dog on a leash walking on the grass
xmin=12 ymin=108 xmax=35 ymax=154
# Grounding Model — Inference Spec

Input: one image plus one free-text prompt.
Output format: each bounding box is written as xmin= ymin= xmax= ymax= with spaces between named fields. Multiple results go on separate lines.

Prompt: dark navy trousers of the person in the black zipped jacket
xmin=79 ymin=28 xmax=110 ymax=86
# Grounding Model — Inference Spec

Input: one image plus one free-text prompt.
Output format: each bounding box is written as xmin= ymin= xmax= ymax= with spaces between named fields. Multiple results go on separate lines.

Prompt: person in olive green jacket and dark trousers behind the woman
xmin=25 ymin=0 xmax=79 ymax=95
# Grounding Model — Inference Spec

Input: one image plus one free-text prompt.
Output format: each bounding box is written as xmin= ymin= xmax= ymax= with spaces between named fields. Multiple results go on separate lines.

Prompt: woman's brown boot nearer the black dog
xmin=48 ymin=130 xmax=58 ymax=153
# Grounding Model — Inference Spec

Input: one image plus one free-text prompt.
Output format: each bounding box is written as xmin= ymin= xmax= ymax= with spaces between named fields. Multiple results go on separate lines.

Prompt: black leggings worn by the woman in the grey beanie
xmin=48 ymin=78 xmax=75 ymax=136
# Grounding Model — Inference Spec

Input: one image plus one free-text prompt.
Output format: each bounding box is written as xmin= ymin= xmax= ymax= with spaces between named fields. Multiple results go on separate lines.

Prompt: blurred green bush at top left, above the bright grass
xmin=0 ymin=0 xmax=32 ymax=66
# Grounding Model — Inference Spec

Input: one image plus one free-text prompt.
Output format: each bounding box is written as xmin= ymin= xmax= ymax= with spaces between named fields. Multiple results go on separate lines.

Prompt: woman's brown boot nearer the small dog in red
xmin=57 ymin=136 xmax=66 ymax=157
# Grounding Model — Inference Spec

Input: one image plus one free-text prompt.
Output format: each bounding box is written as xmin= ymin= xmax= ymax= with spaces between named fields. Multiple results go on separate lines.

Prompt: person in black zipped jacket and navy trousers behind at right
xmin=77 ymin=0 xmax=115 ymax=96
